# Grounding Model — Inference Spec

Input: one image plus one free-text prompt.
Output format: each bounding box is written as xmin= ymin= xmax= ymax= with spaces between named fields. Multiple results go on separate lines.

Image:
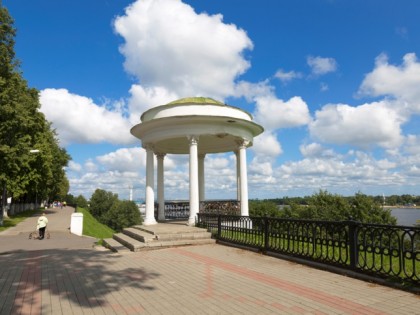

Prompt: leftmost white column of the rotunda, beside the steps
xmin=143 ymin=144 xmax=157 ymax=225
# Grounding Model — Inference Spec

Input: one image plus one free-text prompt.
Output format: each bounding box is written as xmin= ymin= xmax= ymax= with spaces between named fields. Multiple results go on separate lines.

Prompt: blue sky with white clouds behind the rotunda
xmin=3 ymin=0 xmax=420 ymax=200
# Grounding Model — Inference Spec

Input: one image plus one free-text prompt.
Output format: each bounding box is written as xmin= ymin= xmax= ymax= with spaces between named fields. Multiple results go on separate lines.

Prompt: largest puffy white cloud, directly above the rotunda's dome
xmin=114 ymin=0 xmax=253 ymax=99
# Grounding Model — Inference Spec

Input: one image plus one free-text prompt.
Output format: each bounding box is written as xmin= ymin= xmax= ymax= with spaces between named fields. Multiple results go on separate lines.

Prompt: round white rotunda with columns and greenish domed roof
xmin=131 ymin=97 xmax=264 ymax=225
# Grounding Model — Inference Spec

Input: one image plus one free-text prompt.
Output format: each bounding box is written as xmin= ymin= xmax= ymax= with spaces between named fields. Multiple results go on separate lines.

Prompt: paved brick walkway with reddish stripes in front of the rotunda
xmin=0 ymin=209 xmax=420 ymax=315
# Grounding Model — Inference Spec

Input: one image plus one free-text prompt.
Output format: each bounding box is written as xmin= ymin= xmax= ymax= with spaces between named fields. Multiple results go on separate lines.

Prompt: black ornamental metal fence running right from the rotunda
xmin=197 ymin=213 xmax=420 ymax=287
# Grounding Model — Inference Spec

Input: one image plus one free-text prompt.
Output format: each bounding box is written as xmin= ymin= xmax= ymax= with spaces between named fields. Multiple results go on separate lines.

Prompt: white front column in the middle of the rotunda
xmin=188 ymin=136 xmax=199 ymax=225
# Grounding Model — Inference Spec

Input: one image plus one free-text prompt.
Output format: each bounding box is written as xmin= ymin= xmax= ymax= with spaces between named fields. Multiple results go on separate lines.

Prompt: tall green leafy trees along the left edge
xmin=0 ymin=3 xmax=70 ymax=225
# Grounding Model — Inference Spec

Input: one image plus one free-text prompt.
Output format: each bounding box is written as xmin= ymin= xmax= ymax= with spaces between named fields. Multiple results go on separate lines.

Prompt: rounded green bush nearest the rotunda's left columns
xmin=105 ymin=200 xmax=142 ymax=231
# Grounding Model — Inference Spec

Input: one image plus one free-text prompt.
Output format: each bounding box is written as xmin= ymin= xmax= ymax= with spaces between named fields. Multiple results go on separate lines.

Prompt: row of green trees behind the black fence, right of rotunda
xmin=249 ymin=190 xmax=397 ymax=225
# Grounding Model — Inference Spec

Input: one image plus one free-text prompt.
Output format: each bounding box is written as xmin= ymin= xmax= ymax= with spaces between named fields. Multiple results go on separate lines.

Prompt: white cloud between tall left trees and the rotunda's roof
xmin=40 ymin=89 xmax=135 ymax=146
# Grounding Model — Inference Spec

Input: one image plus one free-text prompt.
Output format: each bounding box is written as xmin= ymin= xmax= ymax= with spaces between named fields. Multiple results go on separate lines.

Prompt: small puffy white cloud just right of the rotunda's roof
xmin=254 ymin=95 xmax=310 ymax=130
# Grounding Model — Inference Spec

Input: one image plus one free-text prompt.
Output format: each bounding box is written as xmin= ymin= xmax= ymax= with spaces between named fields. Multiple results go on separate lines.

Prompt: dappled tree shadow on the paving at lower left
xmin=0 ymin=249 xmax=159 ymax=314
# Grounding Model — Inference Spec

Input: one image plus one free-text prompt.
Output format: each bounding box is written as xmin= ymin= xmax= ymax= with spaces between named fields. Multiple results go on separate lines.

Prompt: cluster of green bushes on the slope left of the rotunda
xmin=66 ymin=189 xmax=142 ymax=231
